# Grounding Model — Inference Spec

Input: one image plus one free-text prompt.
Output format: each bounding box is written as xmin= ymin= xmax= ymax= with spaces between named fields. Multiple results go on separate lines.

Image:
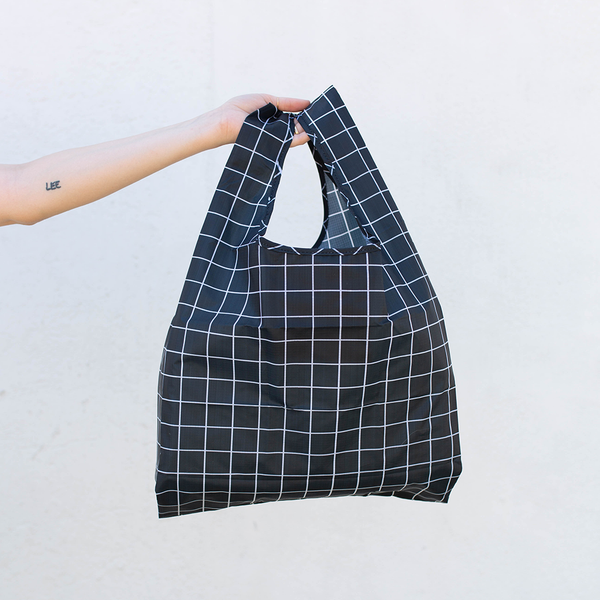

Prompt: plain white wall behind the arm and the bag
xmin=0 ymin=0 xmax=600 ymax=600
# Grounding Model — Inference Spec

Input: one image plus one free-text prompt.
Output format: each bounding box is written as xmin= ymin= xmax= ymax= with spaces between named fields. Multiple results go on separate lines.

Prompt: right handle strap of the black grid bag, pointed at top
xmin=298 ymin=86 xmax=415 ymax=257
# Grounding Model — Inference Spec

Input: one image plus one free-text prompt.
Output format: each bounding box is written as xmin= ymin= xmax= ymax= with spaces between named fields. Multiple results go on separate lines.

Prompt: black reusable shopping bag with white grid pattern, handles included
xmin=156 ymin=88 xmax=461 ymax=517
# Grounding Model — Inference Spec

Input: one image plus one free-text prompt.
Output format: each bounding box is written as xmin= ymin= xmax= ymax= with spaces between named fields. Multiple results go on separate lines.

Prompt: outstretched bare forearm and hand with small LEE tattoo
xmin=0 ymin=94 xmax=309 ymax=225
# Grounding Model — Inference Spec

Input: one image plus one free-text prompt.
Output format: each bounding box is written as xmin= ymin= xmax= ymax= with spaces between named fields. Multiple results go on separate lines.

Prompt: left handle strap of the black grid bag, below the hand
xmin=196 ymin=104 xmax=294 ymax=248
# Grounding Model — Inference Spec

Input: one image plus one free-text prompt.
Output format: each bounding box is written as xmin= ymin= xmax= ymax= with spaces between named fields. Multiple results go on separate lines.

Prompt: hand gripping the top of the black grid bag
xmin=217 ymin=94 xmax=310 ymax=147
